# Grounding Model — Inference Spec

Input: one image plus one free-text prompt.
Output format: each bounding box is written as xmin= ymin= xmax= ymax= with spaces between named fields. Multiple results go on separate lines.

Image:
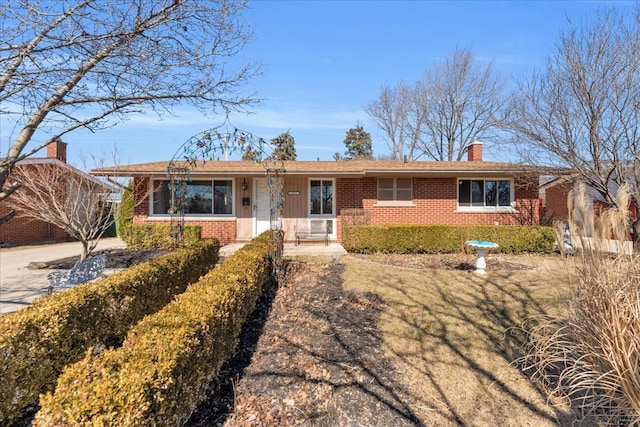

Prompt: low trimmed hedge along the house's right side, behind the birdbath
xmin=342 ymin=225 xmax=555 ymax=254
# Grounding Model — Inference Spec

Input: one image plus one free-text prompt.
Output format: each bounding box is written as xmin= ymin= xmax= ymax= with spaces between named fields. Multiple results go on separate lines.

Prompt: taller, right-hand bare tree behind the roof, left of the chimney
xmin=409 ymin=49 xmax=505 ymax=161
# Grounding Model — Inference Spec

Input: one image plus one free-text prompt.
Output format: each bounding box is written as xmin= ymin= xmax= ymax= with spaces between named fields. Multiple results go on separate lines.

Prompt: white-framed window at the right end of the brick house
xmin=458 ymin=179 xmax=512 ymax=208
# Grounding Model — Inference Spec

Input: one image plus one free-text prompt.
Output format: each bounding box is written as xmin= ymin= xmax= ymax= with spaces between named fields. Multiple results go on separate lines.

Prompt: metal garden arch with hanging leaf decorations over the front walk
xmin=167 ymin=120 xmax=285 ymax=280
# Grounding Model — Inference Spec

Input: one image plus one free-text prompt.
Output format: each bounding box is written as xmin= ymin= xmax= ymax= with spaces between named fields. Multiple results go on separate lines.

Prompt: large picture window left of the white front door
xmin=152 ymin=179 xmax=233 ymax=216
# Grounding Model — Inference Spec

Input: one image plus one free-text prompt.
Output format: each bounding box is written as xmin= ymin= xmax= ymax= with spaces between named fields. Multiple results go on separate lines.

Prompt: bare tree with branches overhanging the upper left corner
xmin=0 ymin=0 xmax=257 ymax=222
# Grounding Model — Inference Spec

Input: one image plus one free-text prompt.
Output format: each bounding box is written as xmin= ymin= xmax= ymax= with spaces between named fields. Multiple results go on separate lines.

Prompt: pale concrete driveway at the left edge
xmin=0 ymin=237 xmax=127 ymax=315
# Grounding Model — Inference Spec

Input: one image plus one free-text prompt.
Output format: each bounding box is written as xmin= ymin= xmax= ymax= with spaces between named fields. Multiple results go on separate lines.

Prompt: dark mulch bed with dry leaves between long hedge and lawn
xmin=186 ymin=261 xmax=419 ymax=427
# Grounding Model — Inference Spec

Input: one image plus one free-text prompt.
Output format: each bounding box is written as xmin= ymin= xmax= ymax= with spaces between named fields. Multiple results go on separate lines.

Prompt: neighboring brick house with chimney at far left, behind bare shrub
xmin=0 ymin=141 xmax=112 ymax=245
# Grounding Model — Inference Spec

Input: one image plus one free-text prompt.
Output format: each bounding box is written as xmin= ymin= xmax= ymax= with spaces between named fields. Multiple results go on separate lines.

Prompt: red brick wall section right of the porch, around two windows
xmin=336 ymin=178 xmax=538 ymax=241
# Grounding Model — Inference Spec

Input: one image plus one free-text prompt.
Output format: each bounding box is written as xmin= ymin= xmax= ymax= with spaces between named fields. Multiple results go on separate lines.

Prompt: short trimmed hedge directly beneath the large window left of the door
xmin=121 ymin=224 xmax=202 ymax=251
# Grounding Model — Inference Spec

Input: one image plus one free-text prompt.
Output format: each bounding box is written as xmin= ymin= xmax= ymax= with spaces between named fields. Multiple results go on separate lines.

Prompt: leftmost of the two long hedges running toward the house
xmin=0 ymin=240 xmax=220 ymax=425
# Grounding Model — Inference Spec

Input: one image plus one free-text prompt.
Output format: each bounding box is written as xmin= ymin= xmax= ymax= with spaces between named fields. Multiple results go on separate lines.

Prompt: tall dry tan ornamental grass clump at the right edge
xmin=522 ymin=183 xmax=640 ymax=425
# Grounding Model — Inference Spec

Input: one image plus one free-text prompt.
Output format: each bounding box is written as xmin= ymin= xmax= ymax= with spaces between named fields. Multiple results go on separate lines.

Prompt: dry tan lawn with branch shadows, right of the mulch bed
xmin=343 ymin=255 xmax=572 ymax=426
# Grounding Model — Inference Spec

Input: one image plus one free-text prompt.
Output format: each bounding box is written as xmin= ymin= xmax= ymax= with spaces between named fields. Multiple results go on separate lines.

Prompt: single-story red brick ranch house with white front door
xmin=92 ymin=143 xmax=539 ymax=244
